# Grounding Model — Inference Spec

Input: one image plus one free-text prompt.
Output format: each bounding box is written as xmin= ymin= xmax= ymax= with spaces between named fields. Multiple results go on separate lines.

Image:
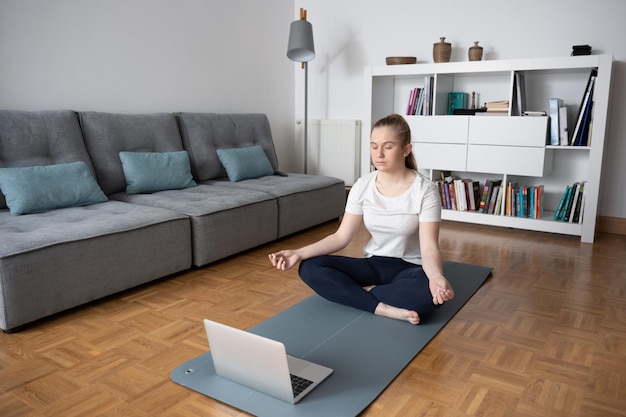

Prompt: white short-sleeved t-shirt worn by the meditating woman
xmin=346 ymin=171 xmax=441 ymax=265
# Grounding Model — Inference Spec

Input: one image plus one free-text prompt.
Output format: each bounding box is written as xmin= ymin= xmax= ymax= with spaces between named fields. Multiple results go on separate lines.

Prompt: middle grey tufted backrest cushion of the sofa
xmin=79 ymin=112 xmax=184 ymax=195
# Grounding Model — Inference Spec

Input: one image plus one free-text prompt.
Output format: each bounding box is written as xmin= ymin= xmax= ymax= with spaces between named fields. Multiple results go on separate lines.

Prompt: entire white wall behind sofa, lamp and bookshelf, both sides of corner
xmin=0 ymin=0 xmax=626 ymax=218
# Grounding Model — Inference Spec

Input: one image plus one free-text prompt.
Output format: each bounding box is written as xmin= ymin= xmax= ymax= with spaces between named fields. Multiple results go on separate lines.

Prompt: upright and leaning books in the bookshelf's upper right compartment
xmin=548 ymin=68 xmax=598 ymax=146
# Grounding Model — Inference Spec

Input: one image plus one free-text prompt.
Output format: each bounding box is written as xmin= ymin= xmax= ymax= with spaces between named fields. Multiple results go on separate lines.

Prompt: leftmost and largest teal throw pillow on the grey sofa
xmin=0 ymin=161 xmax=108 ymax=216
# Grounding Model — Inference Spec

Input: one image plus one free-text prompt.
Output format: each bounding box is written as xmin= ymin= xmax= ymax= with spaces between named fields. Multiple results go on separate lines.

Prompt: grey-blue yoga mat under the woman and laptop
xmin=171 ymin=261 xmax=491 ymax=417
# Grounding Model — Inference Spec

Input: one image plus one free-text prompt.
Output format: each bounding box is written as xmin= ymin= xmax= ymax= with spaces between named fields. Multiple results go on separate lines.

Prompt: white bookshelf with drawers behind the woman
xmin=361 ymin=55 xmax=613 ymax=243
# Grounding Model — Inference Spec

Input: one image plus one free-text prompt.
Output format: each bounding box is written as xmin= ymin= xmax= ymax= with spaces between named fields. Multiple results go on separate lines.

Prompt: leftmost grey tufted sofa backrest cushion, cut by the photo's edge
xmin=0 ymin=110 xmax=93 ymax=209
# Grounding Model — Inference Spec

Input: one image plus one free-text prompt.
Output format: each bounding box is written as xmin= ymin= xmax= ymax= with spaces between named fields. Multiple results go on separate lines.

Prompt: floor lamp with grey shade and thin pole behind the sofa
xmin=287 ymin=8 xmax=315 ymax=174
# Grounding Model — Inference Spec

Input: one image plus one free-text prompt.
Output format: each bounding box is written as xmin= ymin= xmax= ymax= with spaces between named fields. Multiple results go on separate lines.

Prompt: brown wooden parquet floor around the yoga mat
xmin=0 ymin=222 xmax=626 ymax=417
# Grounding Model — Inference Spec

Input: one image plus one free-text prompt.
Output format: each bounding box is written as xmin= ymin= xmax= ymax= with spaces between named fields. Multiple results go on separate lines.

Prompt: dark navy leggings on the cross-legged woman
xmin=299 ymin=255 xmax=435 ymax=314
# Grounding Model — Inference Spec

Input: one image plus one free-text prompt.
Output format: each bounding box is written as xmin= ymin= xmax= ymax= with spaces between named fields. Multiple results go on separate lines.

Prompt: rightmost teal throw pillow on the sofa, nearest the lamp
xmin=217 ymin=145 xmax=274 ymax=181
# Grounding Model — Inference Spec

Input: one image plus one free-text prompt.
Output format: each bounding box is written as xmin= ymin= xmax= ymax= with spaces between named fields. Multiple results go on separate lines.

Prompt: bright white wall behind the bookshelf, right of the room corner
xmin=294 ymin=0 xmax=626 ymax=218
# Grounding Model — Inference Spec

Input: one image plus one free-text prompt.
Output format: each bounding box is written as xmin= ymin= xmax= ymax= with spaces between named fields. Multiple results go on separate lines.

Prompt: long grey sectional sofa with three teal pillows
xmin=0 ymin=110 xmax=345 ymax=332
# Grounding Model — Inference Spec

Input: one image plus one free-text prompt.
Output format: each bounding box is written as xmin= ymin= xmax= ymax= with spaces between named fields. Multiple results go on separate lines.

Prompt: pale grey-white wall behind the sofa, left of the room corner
xmin=0 ymin=0 xmax=299 ymax=171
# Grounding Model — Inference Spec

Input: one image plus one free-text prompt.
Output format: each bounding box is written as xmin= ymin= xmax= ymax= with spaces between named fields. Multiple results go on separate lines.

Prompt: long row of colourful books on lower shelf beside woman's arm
xmin=437 ymin=177 xmax=544 ymax=219
